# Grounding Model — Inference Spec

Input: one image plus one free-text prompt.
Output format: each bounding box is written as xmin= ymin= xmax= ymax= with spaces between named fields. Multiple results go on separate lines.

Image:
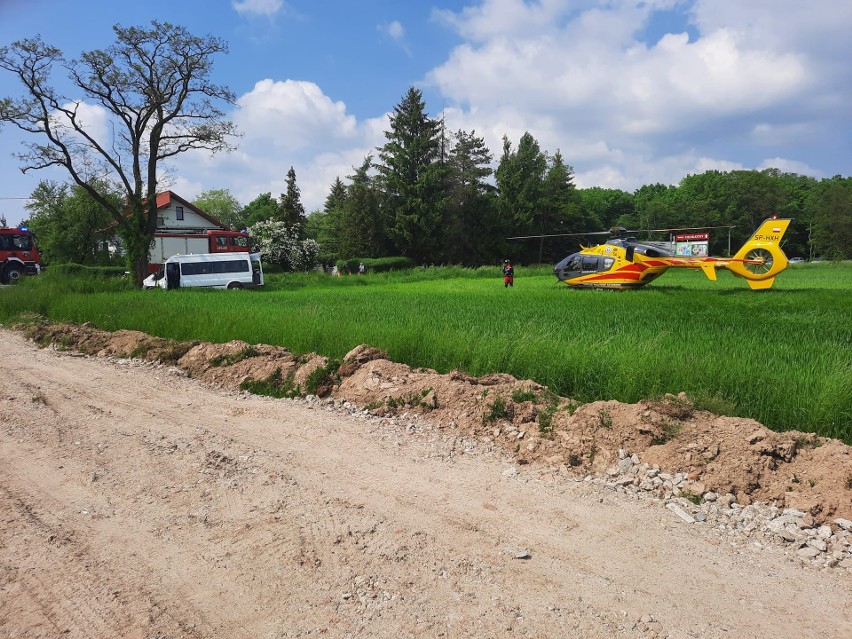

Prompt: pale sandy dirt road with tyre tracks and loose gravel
xmin=0 ymin=331 xmax=852 ymax=639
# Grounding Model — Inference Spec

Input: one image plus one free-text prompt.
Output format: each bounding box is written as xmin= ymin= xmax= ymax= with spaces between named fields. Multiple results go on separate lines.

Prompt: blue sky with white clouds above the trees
xmin=0 ymin=0 xmax=852 ymax=225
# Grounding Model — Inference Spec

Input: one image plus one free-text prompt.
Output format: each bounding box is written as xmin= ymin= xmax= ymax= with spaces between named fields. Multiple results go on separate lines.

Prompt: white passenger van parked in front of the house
xmin=143 ymin=253 xmax=263 ymax=289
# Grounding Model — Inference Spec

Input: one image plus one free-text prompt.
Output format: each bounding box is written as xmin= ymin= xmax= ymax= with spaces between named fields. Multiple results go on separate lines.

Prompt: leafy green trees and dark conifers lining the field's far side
xmin=13 ymin=88 xmax=852 ymax=266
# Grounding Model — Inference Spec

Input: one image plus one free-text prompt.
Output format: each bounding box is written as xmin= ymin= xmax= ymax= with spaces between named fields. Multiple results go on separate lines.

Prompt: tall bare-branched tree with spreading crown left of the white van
xmin=0 ymin=20 xmax=236 ymax=286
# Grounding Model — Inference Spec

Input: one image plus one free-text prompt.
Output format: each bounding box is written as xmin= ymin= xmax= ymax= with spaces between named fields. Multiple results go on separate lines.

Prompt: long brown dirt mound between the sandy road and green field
xmin=18 ymin=321 xmax=852 ymax=522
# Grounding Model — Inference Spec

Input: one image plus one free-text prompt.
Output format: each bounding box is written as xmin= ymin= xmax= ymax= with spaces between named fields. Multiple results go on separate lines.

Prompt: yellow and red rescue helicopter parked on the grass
xmin=508 ymin=217 xmax=791 ymax=290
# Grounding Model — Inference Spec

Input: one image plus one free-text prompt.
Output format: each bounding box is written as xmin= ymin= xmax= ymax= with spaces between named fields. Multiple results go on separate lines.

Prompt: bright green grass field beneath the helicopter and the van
xmin=0 ymin=263 xmax=852 ymax=443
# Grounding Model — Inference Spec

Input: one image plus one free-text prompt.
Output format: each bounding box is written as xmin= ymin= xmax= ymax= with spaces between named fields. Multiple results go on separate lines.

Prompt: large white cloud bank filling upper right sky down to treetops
xmin=427 ymin=0 xmax=852 ymax=190
